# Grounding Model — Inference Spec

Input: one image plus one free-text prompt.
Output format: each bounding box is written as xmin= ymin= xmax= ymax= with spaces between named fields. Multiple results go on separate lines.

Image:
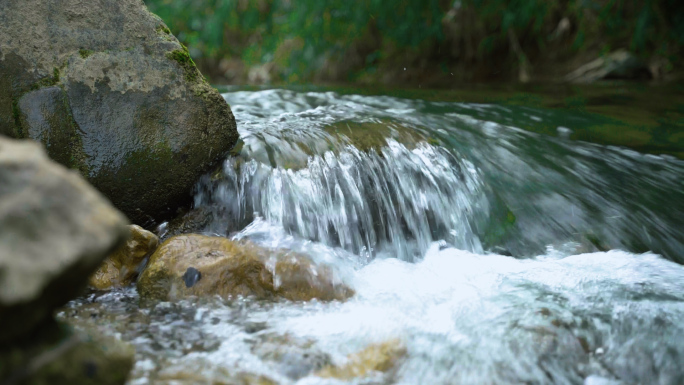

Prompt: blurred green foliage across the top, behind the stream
xmin=145 ymin=0 xmax=684 ymax=79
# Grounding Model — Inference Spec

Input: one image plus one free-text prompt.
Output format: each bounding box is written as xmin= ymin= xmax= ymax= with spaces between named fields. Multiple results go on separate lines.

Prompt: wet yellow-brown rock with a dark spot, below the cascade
xmin=138 ymin=234 xmax=354 ymax=301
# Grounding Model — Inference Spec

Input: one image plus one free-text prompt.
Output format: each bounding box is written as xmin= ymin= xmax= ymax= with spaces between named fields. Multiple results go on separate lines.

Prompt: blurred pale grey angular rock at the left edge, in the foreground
xmin=0 ymin=137 xmax=128 ymax=345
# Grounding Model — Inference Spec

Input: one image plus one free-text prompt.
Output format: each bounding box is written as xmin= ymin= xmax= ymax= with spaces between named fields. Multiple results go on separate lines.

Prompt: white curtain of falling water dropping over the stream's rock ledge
xmin=195 ymin=139 xmax=488 ymax=261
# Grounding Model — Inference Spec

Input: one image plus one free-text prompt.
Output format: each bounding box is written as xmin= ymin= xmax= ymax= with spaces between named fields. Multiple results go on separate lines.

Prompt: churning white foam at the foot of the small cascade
xmin=147 ymin=243 xmax=684 ymax=384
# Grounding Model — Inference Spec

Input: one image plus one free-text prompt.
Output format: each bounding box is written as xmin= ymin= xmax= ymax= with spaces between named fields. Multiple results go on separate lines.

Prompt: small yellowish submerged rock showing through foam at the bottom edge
xmin=316 ymin=339 xmax=406 ymax=380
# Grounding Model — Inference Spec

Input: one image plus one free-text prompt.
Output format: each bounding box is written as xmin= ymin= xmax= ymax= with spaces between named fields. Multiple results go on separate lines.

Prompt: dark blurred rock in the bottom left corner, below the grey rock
xmin=0 ymin=324 xmax=135 ymax=385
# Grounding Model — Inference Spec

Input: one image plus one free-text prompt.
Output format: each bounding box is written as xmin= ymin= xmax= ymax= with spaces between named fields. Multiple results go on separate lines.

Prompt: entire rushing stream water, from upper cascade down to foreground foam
xmin=62 ymin=90 xmax=684 ymax=385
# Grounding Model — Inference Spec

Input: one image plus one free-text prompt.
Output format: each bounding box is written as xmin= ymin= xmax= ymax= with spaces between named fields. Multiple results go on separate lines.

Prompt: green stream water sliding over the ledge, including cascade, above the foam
xmin=187 ymin=90 xmax=684 ymax=262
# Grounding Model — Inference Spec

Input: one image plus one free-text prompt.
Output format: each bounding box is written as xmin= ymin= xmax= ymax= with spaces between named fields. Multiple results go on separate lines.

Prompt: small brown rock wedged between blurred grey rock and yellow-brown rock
xmin=88 ymin=225 xmax=159 ymax=290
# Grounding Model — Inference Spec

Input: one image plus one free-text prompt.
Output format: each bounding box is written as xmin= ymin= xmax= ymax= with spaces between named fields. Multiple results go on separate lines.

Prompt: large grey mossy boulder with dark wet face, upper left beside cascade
xmin=0 ymin=0 xmax=238 ymax=224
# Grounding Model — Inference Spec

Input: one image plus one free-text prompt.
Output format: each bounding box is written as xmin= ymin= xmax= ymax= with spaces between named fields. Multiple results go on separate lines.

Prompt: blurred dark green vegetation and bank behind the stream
xmin=145 ymin=0 xmax=684 ymax=85
